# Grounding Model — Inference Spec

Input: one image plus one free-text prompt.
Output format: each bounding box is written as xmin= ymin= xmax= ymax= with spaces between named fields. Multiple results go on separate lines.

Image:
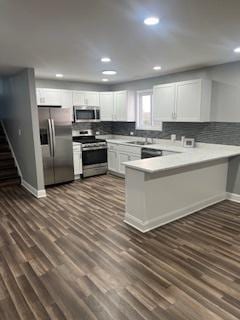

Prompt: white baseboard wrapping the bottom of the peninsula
xmin=124 ymin=193 xmax=228 ymax=233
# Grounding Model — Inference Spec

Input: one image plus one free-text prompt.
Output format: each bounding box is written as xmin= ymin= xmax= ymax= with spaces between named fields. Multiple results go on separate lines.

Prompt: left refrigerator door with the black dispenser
xmin=38 ymin=108 xmax=55 ymax=186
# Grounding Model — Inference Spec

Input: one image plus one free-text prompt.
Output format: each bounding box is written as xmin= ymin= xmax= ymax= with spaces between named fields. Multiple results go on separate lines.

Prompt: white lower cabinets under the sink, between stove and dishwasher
xmin=108 ymin=143 xmax=141 ymax=176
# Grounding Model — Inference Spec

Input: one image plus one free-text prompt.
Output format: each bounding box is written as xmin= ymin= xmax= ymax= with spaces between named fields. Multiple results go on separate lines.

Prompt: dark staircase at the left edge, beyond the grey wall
xmin=0 ymin=124 xmax=21 ymax=188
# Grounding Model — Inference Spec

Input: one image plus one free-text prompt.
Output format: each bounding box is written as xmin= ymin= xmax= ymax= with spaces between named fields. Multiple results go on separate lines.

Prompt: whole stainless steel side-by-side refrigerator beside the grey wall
xmin=38 ymin=107 xmax=74 ymax=186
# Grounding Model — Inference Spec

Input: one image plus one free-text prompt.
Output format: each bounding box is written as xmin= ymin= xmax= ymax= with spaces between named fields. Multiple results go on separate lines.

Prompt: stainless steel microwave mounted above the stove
xmin=73 ymin=106 xmax=101 ymax=122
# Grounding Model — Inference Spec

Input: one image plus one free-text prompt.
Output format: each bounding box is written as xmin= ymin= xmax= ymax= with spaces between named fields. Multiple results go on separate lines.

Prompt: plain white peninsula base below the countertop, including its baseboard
xmin=124 ymin=158 xmax=228 ymax=232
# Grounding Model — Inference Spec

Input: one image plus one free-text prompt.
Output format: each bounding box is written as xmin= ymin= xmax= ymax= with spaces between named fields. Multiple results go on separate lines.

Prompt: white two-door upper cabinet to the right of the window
xmin=153 ymin=79 xmax=211 ymax=124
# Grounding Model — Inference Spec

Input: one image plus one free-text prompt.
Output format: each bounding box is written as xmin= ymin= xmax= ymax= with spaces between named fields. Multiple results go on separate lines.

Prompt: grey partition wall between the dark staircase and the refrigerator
xmin=3 ymin=69 xmax=44 ymax=191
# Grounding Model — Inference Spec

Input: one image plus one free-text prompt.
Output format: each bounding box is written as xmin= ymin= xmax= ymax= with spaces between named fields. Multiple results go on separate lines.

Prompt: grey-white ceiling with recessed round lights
xmin=0 ymin=0 xmax=240 ymax=83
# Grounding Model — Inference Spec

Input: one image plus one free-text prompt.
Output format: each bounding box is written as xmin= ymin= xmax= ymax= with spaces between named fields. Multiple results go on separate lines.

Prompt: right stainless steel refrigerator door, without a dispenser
xmin=50 ymin=108 xmax=74 ymax=183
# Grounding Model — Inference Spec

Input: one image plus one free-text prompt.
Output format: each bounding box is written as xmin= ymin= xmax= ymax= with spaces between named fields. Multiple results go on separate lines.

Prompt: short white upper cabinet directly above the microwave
xmin=73 ymin=91 xmax=99 ymax=107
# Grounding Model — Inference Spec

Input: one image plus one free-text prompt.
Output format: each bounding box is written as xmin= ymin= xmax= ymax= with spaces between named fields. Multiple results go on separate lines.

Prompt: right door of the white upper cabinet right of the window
xmin=176 ymin=80 xmax=201 ymax=121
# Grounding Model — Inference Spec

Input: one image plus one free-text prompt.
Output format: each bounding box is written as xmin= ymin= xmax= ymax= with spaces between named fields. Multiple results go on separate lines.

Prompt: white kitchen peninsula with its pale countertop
xmin=124 ymin=143 xmax=240 ymax=232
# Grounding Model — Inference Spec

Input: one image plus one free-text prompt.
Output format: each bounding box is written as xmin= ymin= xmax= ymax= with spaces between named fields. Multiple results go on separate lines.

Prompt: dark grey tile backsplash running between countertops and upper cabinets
xmin=74 ymin=122 xmax=240 ymax=145
